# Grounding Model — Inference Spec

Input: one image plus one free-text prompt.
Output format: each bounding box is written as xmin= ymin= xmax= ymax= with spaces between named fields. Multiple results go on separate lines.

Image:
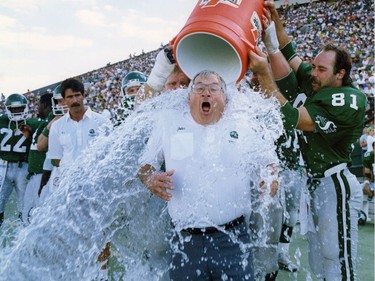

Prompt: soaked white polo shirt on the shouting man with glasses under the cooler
xmin=140 ymin=108 xmax=278 ymax=229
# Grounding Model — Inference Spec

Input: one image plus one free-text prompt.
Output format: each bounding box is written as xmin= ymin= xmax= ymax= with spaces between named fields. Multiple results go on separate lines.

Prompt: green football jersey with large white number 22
xmin=0 ymin=114 xmax=39 ymax=162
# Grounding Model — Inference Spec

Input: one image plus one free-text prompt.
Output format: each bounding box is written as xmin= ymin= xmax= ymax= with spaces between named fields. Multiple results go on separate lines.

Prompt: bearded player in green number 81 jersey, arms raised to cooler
xmin=249 ymin=0 xmax=367 ymax=280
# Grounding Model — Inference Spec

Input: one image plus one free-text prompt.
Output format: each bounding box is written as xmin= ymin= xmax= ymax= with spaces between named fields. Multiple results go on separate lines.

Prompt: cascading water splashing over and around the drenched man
xmin=0 ymin=87 xmax=282 ymax=281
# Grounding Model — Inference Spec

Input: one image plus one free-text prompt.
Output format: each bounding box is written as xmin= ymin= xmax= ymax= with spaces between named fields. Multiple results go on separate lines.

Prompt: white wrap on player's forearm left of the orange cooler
xmin=147 ymin=48 xmax=175 ymax=91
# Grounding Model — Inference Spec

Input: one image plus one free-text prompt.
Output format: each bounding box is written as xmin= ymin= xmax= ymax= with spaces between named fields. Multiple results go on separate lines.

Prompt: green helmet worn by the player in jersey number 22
xmin=5 ymin=94 xmax=29 ymax=121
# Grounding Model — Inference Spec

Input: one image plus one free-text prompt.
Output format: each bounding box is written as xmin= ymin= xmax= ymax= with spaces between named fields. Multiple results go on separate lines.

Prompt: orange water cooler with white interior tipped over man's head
xmin=172 ymin=0 xmax=264 ymax=84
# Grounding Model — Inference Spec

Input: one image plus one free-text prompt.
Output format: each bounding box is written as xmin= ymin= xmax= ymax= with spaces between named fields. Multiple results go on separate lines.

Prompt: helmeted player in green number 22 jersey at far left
xmin=0 ymin=94 xmax=39 ymax=225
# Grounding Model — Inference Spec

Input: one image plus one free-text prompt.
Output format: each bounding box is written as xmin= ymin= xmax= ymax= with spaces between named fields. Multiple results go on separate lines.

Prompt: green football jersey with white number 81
xmin=297 ymin=63 xmax=367 ymax=177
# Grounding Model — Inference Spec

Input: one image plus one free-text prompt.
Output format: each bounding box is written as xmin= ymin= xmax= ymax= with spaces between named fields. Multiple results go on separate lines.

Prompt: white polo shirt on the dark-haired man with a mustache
xmin=47 ymin=107 xmax=112 ymax=167
